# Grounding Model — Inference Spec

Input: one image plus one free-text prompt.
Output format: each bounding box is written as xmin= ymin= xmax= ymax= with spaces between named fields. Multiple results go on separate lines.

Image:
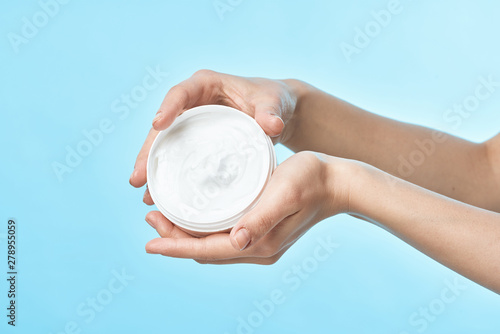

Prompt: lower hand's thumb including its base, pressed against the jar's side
xmin=230 ymin=177 xmax=300 ymax=250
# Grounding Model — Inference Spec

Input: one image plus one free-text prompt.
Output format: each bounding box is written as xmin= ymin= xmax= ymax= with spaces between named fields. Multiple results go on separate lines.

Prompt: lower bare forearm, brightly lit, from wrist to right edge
xmin=349 ymin=160 xmax=500 ymax=293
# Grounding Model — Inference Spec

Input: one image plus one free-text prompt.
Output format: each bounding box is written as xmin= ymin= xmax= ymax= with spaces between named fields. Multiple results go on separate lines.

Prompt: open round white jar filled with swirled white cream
xmin=147 ymin=105 xmax=276 ymax=236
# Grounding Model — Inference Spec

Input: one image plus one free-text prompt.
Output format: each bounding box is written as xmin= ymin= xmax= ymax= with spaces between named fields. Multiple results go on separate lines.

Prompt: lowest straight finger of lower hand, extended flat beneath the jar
xmin=146 ymin=233 xmax=258 ymax=261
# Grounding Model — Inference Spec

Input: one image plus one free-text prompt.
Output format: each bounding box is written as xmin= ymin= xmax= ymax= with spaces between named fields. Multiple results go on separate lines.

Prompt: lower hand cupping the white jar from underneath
xmin=146 ymin=152 xmax=353 ymax=264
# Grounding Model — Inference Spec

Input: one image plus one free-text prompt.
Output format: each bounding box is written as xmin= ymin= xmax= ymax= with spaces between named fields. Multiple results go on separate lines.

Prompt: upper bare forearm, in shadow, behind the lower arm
xmin=284 ymin=80 xmax=500 ymax=210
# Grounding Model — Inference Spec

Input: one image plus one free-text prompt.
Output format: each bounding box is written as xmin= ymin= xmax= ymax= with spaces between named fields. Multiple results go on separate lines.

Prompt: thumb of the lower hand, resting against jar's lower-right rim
xmin=229 ymin=188 xmax=294 ymax=250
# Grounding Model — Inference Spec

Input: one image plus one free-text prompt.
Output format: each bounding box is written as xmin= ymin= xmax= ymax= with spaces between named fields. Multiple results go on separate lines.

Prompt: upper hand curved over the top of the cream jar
xmin=130 ymin=70 xmax=297 ymax=205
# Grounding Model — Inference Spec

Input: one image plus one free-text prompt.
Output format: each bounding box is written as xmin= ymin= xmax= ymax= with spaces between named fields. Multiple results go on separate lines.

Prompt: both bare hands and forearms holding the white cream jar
xmin=130 ymin=70 xmax=500 ymax=293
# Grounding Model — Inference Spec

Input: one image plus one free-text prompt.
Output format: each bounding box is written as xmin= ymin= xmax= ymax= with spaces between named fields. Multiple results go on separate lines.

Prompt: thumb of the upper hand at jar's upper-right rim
xmin=255 ymin=98 xmax=285 ymax=137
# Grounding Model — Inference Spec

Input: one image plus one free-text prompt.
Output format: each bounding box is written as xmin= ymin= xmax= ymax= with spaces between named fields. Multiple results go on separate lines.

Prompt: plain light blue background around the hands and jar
xmin=0 ymin=0 xmax=500 ymax=334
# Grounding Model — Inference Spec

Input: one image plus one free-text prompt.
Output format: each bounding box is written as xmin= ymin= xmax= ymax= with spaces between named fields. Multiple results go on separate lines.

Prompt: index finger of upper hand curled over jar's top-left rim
xmin=153 ymin=70 xmax=222 ymax=130
